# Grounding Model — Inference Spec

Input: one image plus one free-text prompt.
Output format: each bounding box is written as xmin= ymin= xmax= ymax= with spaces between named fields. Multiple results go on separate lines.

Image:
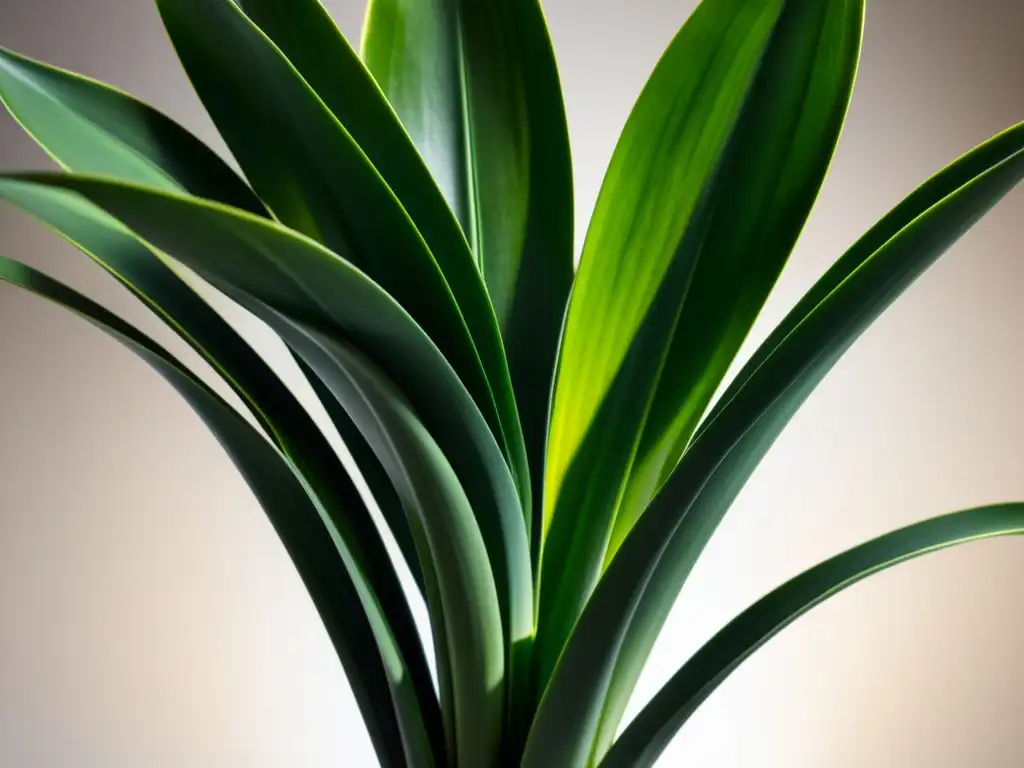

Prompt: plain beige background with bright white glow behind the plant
xmin=0 ymin=0 xmax=1024 ymax=768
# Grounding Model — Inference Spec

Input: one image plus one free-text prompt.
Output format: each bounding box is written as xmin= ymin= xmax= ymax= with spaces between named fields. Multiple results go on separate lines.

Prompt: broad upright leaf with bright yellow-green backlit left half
xmin=541 ymin=0 xmax=863 ymax=692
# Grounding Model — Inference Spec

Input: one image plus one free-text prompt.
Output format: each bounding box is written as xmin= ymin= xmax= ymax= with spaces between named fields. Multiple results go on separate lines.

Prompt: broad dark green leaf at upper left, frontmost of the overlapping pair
xmin=158 ymin=0 xmax=529 ymax=500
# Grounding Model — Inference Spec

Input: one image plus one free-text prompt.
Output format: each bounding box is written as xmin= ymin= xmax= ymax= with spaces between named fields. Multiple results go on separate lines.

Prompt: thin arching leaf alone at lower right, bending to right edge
xmin=600 ymin=504 xmax=1024 ymax=768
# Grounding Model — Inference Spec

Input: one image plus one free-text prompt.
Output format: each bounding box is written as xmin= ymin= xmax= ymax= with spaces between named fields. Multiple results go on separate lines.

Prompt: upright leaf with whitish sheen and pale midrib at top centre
xmin=362 ymin=0 xmax=572 ymax=529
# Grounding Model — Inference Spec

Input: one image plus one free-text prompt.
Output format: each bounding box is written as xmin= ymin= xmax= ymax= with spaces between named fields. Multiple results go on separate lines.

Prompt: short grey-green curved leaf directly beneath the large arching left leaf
xmin=273 ymin=318 xmax=506 ymax=768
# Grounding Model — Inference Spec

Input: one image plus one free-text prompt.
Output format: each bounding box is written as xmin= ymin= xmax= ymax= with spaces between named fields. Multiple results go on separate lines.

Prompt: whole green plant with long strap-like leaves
xmin=0 ymin=0 xmax=1024 ymax=768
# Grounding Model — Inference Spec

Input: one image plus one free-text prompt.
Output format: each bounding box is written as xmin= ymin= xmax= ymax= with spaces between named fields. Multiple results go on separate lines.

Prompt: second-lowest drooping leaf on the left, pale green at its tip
xmin=0 ymin=179 xmax=441 ymax=744
